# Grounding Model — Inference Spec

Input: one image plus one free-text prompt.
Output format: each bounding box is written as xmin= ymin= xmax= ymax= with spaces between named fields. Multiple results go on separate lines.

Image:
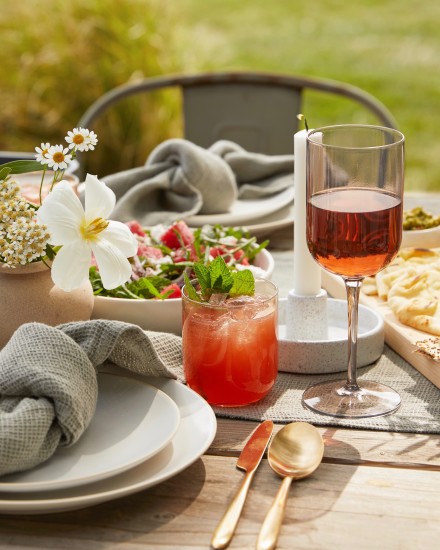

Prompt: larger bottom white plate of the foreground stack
xmin=0 ymin=378 xmax=217 ymax=514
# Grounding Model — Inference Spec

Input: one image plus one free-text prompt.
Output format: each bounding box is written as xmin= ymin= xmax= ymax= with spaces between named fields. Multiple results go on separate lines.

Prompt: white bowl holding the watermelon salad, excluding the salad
xmin=92 ymin=250 xmax=274 ymax=335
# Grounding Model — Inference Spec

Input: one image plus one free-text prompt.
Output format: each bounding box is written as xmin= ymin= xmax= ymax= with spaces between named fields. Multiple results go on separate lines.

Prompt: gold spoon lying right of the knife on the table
xmin=257 ymin=422 xmax=324 ymax=550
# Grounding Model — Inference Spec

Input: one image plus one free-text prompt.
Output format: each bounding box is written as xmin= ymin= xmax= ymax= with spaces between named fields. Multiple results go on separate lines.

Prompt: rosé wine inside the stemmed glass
xmin=307 ymin=187 xmax=402 ymax=277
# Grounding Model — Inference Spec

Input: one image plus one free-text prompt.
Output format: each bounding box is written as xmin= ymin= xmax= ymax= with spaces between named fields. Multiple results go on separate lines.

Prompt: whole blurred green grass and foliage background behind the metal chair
xmin=0 ymin=0 xmax=440 ymax=190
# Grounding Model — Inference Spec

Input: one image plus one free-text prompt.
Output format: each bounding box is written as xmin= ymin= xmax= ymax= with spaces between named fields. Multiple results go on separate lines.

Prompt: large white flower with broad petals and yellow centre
xmin=37 ymin=174 xmax=138 ymax=292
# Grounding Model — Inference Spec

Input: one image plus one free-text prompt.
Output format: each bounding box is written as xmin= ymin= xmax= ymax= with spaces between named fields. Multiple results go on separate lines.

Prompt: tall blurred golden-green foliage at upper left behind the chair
xmin=0 ymin=0 xmax=187 ymax=176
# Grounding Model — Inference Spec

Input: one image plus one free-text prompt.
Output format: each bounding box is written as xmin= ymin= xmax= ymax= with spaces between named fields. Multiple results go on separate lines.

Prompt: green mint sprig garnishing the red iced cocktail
xmin=184 ymin=256 xmax=255 ymax=302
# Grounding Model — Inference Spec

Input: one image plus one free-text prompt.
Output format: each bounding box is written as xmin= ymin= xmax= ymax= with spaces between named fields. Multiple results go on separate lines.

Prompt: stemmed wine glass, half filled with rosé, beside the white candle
xmin=302 ymin=124 xmax=404 ymax=418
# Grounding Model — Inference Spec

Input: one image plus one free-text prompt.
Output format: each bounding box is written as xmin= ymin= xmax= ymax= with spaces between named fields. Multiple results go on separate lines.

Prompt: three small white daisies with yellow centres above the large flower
xmin=35 ymin=128 xmax=98 ymax=171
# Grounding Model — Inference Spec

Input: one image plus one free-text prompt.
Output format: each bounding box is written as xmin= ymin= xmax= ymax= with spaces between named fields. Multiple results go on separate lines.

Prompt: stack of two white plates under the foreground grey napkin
xmin=0 ymin=369 xmax=217 ymax=514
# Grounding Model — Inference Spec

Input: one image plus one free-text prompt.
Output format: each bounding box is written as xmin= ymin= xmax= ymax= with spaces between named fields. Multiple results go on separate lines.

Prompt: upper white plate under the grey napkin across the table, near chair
xmin=186 ymin=186 xmax=295 ymax=227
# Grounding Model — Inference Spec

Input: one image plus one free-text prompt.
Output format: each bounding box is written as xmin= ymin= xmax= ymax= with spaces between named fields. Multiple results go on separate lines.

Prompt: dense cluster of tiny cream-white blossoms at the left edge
xmin=0 ymin=178 xmax=49 ymax=267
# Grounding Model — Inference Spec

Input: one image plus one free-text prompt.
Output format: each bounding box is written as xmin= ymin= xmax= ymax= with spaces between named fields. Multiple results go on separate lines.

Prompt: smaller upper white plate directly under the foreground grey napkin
xmin=0 ymin=373 xmax=180 ymax=493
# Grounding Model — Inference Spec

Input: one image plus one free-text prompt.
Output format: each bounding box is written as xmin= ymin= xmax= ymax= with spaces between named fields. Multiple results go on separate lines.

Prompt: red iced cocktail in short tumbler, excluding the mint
xmin=182 ymin=256 xmax=278 ymax=407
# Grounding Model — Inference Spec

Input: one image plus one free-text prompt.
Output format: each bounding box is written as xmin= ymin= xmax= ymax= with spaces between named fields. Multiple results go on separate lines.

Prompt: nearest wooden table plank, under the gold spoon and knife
xmin=0 ymin=456 xmax=440 ymax=550
